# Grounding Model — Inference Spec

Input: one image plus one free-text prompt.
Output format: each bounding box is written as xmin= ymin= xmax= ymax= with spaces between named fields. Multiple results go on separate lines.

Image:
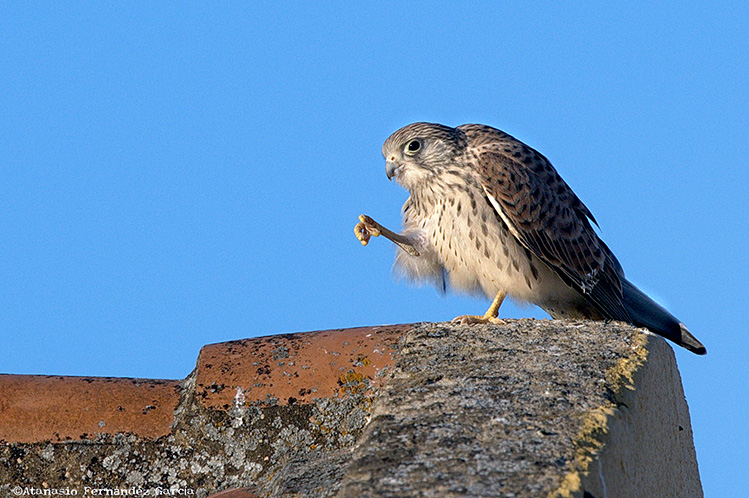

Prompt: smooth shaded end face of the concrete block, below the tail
xmin=568 ymin=330 xmax=702 ymax=497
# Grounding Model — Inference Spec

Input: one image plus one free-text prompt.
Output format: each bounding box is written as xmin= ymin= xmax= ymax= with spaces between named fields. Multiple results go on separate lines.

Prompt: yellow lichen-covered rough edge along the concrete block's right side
xmin=548 ymin=326 xmax=652 ymax=498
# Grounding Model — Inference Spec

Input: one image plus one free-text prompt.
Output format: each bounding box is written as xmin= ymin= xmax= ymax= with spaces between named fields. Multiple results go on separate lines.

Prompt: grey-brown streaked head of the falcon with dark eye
xmin=382 ymin=123 xmax=465 ymax=190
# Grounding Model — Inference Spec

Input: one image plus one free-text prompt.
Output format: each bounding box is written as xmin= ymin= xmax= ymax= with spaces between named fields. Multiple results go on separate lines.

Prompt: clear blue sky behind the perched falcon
xmin=0 ymin=2 xmax=749 ymax=496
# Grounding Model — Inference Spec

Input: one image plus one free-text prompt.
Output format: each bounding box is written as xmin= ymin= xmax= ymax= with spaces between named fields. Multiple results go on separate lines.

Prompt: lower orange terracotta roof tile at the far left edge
xmin=0 ymin=375 xmax=180 ymax=443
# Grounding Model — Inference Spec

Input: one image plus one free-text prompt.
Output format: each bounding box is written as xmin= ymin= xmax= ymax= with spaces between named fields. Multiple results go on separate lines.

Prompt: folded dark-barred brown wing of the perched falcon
xmin=475 ymin=145 xmax=631 ymax=322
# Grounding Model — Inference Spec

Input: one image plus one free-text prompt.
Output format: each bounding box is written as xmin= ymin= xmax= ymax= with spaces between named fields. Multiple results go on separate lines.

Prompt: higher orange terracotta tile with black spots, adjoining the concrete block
xmin=196 ymin=325 xmax=411 ymax=409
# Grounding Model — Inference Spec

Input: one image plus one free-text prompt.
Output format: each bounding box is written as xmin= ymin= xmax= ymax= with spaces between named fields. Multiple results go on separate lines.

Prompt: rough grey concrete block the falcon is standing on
xmin=336 ymin=320 xmax=702 ymax=498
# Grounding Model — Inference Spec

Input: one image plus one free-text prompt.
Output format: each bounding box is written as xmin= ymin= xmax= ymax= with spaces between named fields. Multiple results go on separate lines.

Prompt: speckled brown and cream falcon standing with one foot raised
xmin=354 ymin=122 xmax=707 ymax=355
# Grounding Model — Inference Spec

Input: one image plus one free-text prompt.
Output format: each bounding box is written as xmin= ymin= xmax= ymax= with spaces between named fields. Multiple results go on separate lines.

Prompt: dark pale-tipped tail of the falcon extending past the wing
xmin=622 ymin=279 xmax=707 ymax=354
